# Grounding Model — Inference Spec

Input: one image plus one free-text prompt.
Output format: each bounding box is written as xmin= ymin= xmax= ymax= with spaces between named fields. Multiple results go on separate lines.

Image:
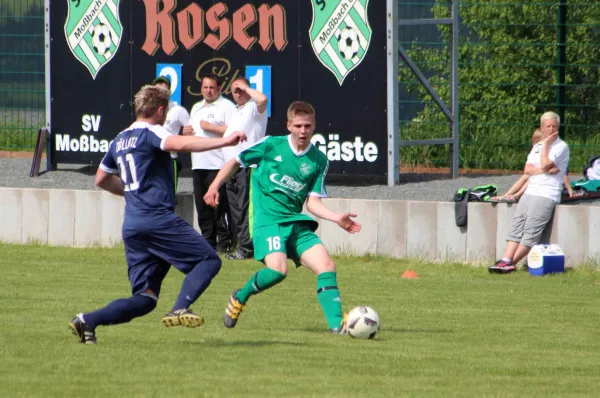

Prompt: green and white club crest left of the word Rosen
xmin=65 ymin=0 xmax=123 ymax=79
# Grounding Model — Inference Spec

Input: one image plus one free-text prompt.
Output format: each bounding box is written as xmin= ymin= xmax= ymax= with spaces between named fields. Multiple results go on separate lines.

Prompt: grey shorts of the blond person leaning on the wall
xmin=508 ymin=195 xmax=557 ymax=247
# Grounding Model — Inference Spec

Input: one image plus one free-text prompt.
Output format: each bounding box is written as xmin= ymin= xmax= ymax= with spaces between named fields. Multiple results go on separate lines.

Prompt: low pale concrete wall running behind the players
xmin=0 ymin=188 xmax=600 ymax=266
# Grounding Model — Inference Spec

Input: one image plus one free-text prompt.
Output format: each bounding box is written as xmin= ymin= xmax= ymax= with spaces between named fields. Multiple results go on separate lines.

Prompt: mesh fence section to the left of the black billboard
xmin=0 ymin=0 xmax=45 ymax=150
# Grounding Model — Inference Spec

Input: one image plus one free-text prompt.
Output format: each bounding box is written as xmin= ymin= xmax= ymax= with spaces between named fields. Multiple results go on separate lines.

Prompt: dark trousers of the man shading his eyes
xmin=226 ymin=168 xmax=254 ymax=253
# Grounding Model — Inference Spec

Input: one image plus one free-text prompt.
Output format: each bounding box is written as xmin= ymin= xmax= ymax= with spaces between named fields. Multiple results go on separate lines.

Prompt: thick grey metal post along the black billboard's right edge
xmin=386 ymin=0 xmax=400 ymax=186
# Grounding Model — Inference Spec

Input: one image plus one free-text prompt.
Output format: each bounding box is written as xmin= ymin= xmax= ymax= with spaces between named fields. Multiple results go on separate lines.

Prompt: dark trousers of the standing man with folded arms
xmin=192 ymin=170 xmax=231 ymax=249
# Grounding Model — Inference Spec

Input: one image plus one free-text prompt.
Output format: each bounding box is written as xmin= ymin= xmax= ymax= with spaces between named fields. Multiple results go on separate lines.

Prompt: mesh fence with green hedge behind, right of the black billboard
xmin=398 ymin=0 xmax=600 ymax=174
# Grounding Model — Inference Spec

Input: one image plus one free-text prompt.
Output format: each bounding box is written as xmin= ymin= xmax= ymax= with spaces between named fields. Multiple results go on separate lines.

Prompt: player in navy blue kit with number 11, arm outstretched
xmin=70 ymin=86 xmax=246 ymax=344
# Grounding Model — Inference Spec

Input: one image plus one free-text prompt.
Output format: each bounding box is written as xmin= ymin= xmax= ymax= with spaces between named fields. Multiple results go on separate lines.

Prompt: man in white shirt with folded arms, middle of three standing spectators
xmin=183 ymin=74 xmax=235 ymax=252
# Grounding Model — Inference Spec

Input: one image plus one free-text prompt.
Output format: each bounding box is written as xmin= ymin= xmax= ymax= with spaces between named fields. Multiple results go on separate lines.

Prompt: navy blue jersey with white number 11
xmin=100 ymin=122 xmax=175 ymax=237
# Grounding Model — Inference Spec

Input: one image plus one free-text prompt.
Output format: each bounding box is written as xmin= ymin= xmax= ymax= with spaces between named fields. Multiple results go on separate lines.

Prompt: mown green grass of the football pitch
xmin=0 ymin=245 xmax=600 ymax=397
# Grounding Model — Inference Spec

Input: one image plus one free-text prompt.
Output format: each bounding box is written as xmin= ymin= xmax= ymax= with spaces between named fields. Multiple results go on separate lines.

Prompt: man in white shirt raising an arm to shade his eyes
xmin=219 ymin=77 xmax=269 ymax=260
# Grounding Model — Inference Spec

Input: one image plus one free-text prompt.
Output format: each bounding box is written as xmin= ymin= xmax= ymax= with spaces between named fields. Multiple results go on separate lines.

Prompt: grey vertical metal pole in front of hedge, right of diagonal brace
xmin=450 ymin=0 xmax=459 ymax=178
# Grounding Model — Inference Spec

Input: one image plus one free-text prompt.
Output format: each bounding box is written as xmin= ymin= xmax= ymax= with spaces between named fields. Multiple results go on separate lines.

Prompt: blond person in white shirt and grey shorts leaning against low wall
xmin=488 ymin=112 xmax=569 ymax=274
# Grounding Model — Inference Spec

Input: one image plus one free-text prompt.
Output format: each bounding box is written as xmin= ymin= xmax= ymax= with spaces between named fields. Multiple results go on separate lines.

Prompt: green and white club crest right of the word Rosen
xmin=309 ymin=0 xmax=373 ymax=86
